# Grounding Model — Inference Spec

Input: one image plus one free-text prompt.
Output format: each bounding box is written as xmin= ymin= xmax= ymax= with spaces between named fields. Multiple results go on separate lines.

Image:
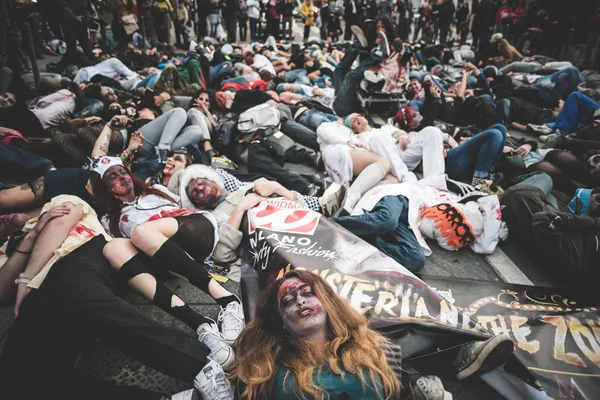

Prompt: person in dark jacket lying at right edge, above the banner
xmin=500 ymin=174 xmax=600 ymax=287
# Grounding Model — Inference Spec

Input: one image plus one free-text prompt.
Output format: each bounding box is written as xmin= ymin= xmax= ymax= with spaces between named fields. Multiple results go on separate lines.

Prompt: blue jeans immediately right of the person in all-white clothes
xmin=446 ymin=124 xmax=507 ymax=180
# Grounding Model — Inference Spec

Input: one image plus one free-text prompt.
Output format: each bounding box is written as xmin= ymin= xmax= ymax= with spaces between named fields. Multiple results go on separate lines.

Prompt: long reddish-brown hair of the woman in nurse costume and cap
xmin=90 ymin=166 xmax=175 ymax=237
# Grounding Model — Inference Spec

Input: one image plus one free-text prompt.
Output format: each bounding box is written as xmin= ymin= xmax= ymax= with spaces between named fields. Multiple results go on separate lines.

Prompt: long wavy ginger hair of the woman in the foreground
xmin=232 ymin=270 xmax=401 ymax=400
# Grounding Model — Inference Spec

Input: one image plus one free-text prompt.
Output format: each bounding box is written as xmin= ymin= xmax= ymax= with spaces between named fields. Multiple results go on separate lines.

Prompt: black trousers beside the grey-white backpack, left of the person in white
xmin=248 ymin=142 xmax=311 ymax=194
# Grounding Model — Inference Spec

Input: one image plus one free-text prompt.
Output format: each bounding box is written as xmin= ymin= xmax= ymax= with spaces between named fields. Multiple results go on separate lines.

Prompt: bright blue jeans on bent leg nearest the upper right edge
xmin=547 ymin=92 xmax=600 ymax=134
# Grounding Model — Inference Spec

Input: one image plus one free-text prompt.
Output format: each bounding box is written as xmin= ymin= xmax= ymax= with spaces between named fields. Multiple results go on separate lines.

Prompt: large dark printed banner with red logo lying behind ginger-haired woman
xmin=244 ymin=199 xmax=600 ymax=399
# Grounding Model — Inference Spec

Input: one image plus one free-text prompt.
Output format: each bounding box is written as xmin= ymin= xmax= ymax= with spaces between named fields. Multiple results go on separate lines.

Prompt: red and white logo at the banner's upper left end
xmin=248 ymin=199 xmax=321 ymax=235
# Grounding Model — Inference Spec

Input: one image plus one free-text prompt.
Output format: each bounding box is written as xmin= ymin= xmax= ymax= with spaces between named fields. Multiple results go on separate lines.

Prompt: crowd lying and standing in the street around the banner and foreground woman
xmin=0 ymin=0 xmax=600 ymax=400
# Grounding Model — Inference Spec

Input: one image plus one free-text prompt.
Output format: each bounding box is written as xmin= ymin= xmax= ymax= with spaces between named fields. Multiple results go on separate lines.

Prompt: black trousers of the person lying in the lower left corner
xmin=0 ymin=236 xmax=209 ymax=400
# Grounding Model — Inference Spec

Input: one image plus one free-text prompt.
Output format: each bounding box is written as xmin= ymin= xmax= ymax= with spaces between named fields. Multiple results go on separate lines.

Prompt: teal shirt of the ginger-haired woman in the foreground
xmin=271 ymin=366 xmax=383 ymax=400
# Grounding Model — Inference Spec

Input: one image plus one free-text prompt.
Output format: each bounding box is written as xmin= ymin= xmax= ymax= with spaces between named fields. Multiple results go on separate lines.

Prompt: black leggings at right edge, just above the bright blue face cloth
xmin=528 ymin=150 xmax=600 ymax=196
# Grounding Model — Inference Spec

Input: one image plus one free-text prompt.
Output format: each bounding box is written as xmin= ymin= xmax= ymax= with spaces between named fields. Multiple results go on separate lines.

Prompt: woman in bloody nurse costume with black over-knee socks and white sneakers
xmin=91 ymin=157 xmax=244 ymax=368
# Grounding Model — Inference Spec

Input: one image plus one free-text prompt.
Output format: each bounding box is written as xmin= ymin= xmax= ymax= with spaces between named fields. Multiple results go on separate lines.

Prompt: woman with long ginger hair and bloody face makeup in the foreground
xmin=232 ymin=270 xmax=401 ymax=400
